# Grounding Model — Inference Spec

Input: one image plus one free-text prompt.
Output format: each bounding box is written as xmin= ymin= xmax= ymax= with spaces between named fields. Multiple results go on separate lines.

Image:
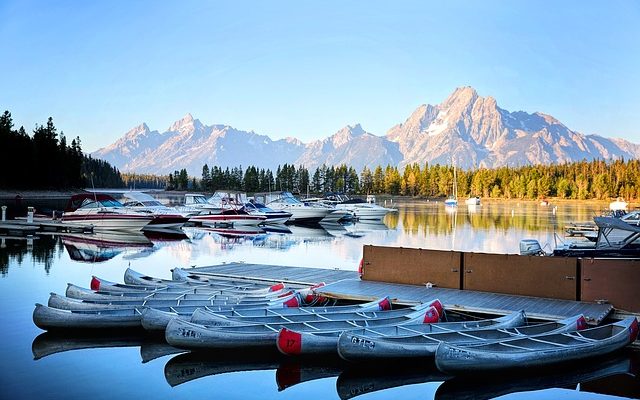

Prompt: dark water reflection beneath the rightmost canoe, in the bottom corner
xmin=435 ymin=352 xmax=637 ymax=400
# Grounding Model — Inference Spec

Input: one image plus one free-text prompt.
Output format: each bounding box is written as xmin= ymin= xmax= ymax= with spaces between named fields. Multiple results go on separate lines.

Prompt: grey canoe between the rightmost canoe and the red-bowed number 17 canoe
xmin=337 ymin=313 xmax=587 ymax=361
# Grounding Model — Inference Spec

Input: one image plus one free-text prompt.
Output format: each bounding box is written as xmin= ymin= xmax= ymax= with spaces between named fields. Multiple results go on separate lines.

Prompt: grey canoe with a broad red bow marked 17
xmin=278 ymin=311 xmax=526 ymax=355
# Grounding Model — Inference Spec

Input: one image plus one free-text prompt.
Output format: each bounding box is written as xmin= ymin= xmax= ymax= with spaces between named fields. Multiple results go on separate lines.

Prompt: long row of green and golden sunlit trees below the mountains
xmin=168 ymin=159 xmax=640 ymax=200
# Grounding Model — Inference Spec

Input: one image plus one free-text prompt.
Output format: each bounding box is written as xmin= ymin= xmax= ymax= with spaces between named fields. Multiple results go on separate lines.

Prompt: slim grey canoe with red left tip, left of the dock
xmin=90 ymin=276 xmax=284 ymax=294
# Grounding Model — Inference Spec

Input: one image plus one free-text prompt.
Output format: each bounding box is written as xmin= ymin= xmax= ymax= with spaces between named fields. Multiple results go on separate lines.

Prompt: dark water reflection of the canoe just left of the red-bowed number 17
xmin=164 ymin=351 xmax=279 ymax=386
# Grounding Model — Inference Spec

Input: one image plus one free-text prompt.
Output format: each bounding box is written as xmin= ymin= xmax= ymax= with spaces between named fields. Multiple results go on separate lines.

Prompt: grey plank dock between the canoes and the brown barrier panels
xmin=187 ymin=263 xmax=613 ymax=324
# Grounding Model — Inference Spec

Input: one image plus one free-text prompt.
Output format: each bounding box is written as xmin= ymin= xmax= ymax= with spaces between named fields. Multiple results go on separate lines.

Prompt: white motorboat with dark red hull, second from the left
xmin=122 ymin=192 xmax=190 ymax=231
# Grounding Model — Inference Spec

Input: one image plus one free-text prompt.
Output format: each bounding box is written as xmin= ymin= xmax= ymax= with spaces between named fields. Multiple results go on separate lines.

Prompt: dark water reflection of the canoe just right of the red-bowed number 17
xmin=336 ymin=363 xmax=449 ymax=400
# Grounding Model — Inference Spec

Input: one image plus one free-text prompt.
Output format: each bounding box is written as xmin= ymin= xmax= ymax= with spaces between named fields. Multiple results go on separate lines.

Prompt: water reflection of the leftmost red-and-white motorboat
xmin=62 ymin=231 xmax=153 ymax=263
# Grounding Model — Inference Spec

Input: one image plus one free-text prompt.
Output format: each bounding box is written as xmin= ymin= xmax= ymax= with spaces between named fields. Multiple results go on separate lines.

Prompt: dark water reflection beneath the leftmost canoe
xmin=31 ymin=331 xmax=183 ymax=362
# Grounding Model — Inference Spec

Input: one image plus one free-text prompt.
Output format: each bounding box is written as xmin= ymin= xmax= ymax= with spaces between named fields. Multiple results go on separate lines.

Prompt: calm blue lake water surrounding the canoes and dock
xmin=0 ymin=200 xmax=640 ymax=399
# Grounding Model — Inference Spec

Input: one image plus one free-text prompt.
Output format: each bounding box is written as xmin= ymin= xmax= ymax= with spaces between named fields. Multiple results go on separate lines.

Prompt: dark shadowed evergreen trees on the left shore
xmin=0 ymin=111 xmax=123 ymax=189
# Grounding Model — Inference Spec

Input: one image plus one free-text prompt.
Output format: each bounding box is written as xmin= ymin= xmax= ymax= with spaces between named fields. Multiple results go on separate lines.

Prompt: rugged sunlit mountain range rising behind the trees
xmin=92 ymin=86 xmax=640 ymax=176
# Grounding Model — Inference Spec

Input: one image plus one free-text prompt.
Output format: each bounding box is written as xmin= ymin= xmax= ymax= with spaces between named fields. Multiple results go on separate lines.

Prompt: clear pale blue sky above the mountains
xmin=0 ymin=0 xmax=640 ymax=151
